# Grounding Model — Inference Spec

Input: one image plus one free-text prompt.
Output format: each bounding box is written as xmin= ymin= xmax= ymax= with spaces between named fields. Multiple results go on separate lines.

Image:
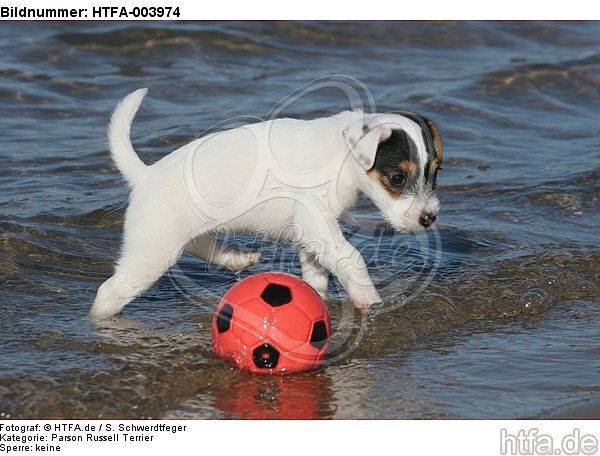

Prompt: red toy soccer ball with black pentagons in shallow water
xmin=212 ymin=272 xmax=331 ymax=374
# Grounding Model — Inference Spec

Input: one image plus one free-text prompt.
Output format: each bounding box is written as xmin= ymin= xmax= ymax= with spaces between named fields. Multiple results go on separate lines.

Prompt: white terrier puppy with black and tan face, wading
xmin=90 ymin=89 xmax=442 ymax=319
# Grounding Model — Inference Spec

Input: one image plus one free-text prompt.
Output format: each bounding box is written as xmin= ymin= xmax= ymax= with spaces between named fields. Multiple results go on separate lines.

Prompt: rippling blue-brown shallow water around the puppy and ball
xmin=0 ymin=22 xmax=600 ymax=418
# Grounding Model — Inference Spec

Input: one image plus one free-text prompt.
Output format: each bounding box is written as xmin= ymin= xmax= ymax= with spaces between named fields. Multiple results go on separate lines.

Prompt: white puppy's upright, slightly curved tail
xmin=107 ymin=89 xmax=148 ymax=187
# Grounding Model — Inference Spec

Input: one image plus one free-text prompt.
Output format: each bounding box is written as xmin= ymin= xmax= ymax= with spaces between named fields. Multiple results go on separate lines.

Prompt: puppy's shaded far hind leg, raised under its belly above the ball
xmin=185 ymin=234 xmax=260 ymax=271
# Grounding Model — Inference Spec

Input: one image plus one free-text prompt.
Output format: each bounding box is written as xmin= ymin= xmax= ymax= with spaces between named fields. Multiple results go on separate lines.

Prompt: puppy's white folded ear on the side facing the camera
xmin=343 ymin=115 xmax=392 ymax=170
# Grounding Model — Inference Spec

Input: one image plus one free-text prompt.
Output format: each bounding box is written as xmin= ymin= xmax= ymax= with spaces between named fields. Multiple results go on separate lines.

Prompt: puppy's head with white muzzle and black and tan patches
xmin=344 ymin=112 xmax=442 ymax=233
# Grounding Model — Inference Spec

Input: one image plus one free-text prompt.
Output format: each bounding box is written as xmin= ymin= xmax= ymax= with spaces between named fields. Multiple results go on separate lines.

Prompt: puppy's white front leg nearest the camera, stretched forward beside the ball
xmin=297 ymin=210 xmax=381 ymax=309
